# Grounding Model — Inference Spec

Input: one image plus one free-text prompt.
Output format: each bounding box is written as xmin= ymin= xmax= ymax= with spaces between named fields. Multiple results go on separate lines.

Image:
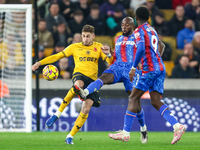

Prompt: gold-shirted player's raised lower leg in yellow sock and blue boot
xmin=46 ymin=87 xmax=76 ymax=127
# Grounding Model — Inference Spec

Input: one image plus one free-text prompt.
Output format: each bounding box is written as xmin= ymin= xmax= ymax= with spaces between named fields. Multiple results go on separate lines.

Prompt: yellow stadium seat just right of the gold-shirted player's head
xmin=94 ymin=35 xmax=114 ymax=47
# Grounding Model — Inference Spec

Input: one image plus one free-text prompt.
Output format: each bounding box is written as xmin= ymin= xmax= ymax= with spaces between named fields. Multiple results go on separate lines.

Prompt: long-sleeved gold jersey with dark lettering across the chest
xmin=40 ymin=42 xmax=113 ymax=80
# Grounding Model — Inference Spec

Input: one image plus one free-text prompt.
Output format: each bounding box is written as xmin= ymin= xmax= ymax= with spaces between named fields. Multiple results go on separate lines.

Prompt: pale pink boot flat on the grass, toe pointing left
xmin=108 ymin=130 xmax=130 ymax=142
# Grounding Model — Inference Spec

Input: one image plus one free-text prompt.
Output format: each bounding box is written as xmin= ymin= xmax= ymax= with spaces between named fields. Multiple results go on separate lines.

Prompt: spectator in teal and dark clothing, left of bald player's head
xmin=106 ymin=7 xmax=124 ymax=36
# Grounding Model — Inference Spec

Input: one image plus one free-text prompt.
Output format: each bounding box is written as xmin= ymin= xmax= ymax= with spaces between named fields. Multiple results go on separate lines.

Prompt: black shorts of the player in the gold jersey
xmin=72 ymin=72 xmax=101 ymax=107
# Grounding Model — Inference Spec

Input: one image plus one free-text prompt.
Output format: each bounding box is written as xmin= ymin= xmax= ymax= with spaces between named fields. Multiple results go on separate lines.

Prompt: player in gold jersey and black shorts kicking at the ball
xmin=31 ymin=25 xmax=113 ymax=144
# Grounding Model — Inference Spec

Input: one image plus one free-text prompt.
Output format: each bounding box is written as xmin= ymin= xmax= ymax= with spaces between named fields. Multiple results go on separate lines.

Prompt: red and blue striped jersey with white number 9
xmin=134 ymin=23 xmax=165 ymax=72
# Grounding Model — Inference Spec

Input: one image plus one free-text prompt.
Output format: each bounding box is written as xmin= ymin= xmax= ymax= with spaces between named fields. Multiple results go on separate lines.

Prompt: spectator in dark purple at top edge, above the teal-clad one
xmin=100 ymin=0 xmax=126 ymax=18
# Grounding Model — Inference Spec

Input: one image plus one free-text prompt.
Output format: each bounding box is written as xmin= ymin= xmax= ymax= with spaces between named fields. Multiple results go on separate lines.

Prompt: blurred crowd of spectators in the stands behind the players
xmin=0 ymin=0 xmax=200 ymax=79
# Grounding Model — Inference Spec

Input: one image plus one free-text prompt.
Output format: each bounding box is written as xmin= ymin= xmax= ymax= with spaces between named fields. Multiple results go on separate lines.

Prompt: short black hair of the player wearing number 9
xmin=136 ymin=6 xmax=150 ymax=21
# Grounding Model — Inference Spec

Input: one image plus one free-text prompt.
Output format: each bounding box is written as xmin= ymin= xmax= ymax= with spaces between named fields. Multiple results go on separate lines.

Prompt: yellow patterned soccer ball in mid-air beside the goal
xmin=42 ymin=65 xmax=59 ymax=81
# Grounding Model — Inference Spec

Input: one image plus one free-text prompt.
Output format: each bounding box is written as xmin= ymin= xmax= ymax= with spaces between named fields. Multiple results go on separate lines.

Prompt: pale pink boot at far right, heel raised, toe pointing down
xmin=171 ymin=123 xmax=186 ymax=144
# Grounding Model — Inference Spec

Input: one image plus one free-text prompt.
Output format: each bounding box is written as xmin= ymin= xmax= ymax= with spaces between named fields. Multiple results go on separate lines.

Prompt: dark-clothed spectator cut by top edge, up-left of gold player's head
xmin=59 ymin=0 xmax=76 ymax=21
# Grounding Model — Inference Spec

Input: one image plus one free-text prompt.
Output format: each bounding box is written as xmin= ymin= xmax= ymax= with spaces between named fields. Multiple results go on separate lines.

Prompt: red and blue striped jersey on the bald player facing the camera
xmin=113 ymin=34 xmax=136 ymax=66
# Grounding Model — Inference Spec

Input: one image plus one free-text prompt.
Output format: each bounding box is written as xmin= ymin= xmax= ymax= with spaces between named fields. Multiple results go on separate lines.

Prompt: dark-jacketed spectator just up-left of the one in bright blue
xmin=169 ymin=5 xmax=187 ymax=37
